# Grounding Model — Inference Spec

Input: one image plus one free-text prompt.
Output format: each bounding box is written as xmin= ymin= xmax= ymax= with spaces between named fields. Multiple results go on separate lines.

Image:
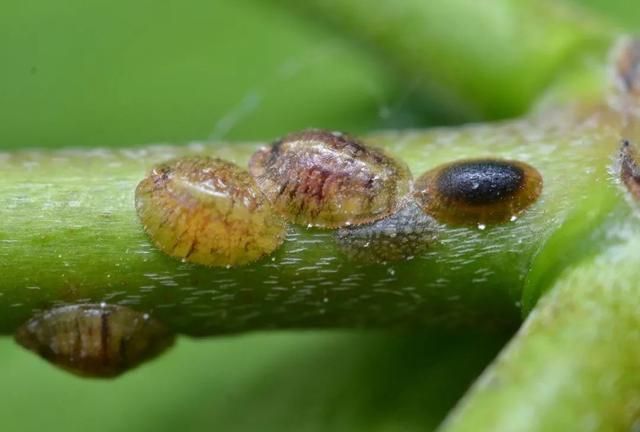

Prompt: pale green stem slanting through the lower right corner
xmin=442 ymin=208 xmax=640 ymax=432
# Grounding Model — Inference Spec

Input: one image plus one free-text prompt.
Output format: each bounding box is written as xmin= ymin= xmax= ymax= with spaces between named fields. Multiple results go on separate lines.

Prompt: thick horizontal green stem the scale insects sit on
xmin=0 ymin=98 xmax=619 ymax=335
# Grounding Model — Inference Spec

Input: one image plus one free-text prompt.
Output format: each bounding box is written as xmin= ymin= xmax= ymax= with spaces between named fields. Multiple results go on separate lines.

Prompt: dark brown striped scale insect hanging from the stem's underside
xmin=15 ymin=304 xmax=174 ymax=378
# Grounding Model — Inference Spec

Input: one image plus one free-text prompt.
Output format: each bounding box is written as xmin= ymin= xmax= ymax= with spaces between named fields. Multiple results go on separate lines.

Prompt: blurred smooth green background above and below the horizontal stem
xmin=0 ymin=0 xmax=640 ymax=431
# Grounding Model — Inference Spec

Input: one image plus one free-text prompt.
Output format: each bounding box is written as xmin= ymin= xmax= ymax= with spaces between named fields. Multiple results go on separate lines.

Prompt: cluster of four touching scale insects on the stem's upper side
xmin=136 ymin=129 xmax=542 ymax=266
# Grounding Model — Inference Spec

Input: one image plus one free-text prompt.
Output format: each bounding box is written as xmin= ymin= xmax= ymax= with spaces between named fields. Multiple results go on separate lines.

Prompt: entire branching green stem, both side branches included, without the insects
xmin=0 ymin=0 xmax=640 ymax=432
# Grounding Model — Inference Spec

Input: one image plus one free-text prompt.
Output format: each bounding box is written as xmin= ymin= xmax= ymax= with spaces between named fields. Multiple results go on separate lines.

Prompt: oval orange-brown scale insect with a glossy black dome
xmin=414 ymin=159 xmax=542 ymax=225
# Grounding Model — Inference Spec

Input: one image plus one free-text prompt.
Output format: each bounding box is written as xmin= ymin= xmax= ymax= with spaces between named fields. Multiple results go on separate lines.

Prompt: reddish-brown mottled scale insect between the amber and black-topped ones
xmin=249 ymin=130 xmax=411 ymax=228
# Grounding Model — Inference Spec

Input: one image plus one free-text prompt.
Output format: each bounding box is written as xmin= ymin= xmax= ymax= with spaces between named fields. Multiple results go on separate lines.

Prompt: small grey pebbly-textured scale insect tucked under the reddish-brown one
xmin=336 ymin=200 xmax=438 ymax=263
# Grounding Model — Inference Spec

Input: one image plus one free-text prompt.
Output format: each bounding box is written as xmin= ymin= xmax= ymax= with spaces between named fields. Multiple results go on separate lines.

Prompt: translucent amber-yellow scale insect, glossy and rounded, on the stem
xmin=136 ymin=157 xmax=286 ymax=266
